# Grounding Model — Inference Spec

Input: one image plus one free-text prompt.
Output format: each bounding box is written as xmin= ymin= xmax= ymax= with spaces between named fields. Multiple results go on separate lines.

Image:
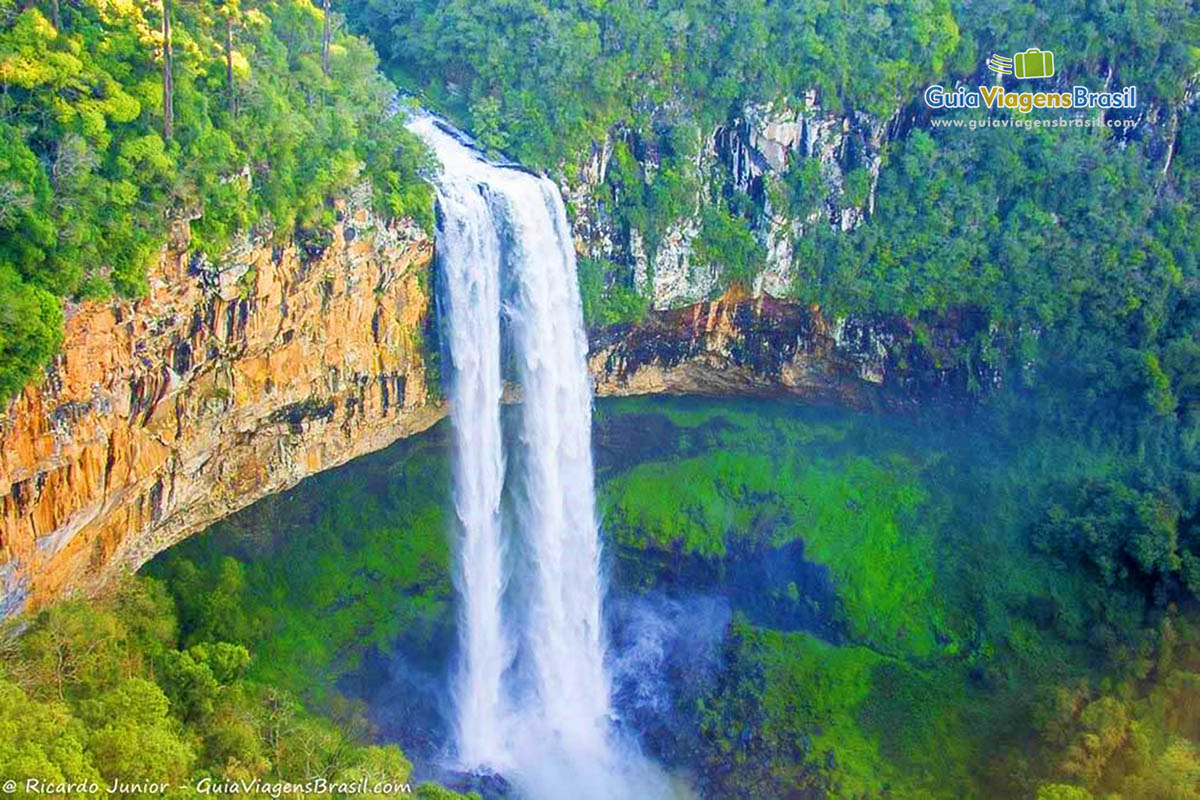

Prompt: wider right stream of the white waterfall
xmin=501 ymin=179 xmax=610 ymax=735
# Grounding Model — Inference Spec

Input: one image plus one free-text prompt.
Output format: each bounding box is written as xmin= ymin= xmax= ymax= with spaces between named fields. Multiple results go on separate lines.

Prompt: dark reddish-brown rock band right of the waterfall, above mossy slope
xmin=589 ymin=295 xmax=1001 ymax=410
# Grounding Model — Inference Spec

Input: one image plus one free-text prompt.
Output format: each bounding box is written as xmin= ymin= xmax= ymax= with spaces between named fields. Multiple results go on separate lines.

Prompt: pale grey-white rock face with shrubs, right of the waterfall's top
xmin=559 ymin=92 xmax=899 ymax=311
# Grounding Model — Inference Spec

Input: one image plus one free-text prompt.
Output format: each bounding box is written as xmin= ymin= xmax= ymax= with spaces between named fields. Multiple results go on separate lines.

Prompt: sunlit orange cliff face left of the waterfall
xmin=0 ymin=190 xmax=442 ymax=616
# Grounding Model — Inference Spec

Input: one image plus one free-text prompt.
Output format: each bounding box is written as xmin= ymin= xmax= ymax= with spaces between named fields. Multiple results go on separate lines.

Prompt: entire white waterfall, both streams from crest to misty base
xmin=409 ymin=116 xmax=665 ymax=800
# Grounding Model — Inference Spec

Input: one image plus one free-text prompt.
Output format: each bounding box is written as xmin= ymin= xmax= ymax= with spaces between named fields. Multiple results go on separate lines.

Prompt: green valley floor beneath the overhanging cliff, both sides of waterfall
xmin=0 ymin=398 xmax=1200 ymax=800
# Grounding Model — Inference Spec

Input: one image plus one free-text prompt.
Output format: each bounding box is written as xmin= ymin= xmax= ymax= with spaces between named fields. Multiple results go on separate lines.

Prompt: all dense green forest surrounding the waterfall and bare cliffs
xmin=7 ymin=0 xmax=1200 ymax=800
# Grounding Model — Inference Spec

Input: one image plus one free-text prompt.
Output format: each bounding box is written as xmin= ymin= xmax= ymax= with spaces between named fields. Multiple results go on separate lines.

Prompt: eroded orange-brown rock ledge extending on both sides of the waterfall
xmin=0 ymin=225 xmax=998 ymax=618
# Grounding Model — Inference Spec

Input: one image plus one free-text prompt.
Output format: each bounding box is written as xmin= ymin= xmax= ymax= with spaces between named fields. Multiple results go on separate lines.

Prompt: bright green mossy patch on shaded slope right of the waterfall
xmin=604 ymin=443 xmax=938 ymax=655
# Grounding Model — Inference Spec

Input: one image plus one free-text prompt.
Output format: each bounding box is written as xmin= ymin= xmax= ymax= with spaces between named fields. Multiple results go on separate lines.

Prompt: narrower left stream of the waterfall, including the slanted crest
xmin=414 ymin=118 xmax=511 ymax=769
